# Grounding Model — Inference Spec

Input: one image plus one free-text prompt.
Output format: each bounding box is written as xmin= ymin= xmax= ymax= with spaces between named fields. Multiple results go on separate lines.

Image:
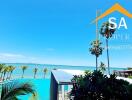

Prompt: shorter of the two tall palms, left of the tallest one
xmin=89 ymin=40 xmax=103 ymax=70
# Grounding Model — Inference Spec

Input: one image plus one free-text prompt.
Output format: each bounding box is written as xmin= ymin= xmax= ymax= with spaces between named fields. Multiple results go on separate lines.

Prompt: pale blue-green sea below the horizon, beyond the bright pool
xmin=1 ymin=63 xmax=127 ymax=79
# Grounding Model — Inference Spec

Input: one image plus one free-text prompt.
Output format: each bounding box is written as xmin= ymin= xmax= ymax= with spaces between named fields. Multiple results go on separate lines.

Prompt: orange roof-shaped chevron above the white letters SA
xmin=93 ymin=3 xmax=132 ymax=22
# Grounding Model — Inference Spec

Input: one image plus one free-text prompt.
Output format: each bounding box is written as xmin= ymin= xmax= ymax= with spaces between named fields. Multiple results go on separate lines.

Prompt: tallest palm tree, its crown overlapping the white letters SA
xmin=100 ymin=22 xmax=116 ymax=75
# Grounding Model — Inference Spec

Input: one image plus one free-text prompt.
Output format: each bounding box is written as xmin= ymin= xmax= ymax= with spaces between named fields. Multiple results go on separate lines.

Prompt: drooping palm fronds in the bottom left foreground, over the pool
xmin=0 ymin=81 xmax=35 ymax=100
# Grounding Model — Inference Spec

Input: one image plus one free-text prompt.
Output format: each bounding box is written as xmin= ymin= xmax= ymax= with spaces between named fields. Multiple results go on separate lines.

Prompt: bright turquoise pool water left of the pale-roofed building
xmin=18 ymin=79 xmax=50 ymax=100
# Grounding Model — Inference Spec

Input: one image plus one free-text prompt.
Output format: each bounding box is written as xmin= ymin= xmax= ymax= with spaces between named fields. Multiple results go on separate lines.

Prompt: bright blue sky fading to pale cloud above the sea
xmin=0 ymin=0 xmax=132 ymax=67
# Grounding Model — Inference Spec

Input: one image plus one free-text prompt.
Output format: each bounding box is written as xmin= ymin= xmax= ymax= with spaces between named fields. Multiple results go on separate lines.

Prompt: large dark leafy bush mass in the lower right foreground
xmin=71 ymin=71 xmax=132 ymax=100
